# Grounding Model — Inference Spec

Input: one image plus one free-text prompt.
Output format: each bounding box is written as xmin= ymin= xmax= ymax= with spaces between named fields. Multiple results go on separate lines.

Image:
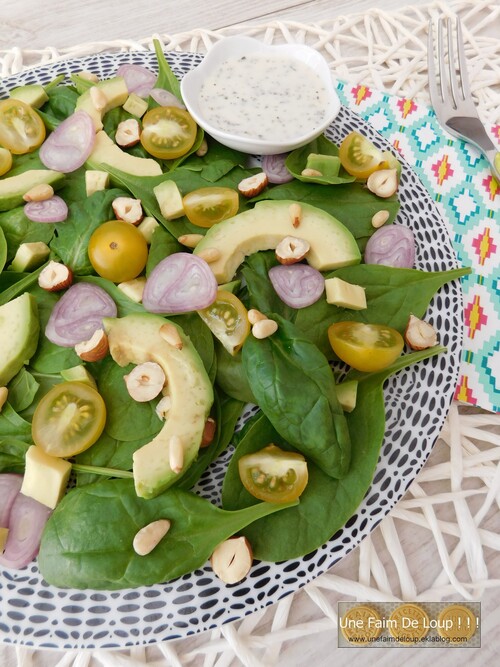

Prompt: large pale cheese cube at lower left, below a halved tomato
xmin=21 ymin=445 xmax=71 ymax=509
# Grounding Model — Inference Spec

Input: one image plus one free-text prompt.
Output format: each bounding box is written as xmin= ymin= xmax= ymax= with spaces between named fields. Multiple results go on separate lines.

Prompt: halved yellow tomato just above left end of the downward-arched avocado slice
xmin=182 ymin=187 xmax=240 ymax=227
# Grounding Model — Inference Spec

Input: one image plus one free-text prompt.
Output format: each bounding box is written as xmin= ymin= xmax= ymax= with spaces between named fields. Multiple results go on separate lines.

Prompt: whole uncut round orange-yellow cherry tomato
xmin=88 ymin=220 xmax=148 ymax=283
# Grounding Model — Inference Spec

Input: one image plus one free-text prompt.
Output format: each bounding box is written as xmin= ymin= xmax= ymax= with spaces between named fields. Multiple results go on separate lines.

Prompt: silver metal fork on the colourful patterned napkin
xmin=427 ymin=17 xmax=500 ymax=185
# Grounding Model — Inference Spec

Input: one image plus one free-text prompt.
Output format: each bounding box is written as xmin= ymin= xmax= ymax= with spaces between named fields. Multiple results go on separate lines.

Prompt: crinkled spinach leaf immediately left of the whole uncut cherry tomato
xmin=50 ymin=189 xmax=127 ymax=276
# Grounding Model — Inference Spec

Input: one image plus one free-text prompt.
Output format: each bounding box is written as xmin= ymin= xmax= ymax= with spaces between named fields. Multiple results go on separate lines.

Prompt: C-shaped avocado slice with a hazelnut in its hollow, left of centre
xmin=103 ymin=313 xmax=214 ymax=498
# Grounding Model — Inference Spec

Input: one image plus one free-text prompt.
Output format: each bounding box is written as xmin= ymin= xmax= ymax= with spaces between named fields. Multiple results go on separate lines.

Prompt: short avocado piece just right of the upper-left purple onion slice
xmin=86 ymin=130 xmax=163 ymax=176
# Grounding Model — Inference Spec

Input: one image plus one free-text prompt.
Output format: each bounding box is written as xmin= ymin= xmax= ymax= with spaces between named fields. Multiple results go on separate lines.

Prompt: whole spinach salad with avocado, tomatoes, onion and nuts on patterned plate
xmin=0 ymin=43 xmax=469 ymax=589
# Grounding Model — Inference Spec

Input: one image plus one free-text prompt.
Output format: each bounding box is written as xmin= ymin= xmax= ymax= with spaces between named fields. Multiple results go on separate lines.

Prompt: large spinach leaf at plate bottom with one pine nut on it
xmin=38 ymin=480 xmax=296 ymax=590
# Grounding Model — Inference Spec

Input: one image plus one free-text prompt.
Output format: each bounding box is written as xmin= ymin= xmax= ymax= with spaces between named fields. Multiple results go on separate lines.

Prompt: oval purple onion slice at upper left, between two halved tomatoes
xmin=40 ymin=111 xmax=95 ymax=174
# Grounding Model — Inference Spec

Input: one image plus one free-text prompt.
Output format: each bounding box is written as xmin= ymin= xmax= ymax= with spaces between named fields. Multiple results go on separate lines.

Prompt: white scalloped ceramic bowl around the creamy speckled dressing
xmin=181 ymin=37 xmax=340 ymax=155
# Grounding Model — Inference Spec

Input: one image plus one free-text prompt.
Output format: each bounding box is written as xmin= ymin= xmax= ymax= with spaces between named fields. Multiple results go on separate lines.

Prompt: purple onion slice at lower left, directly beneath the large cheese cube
xmin=0 ymin=493 xmax=52 ymax=570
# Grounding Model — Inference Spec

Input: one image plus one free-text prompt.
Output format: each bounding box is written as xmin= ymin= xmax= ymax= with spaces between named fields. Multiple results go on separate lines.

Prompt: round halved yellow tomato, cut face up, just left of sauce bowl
xmin=141 ymin=107 xmax=197 ymax=160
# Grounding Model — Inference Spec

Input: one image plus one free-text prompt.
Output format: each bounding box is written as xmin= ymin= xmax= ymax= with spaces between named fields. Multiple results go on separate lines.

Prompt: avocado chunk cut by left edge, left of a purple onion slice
xmin=0 ymin=292 xmax=40 ymax=387
